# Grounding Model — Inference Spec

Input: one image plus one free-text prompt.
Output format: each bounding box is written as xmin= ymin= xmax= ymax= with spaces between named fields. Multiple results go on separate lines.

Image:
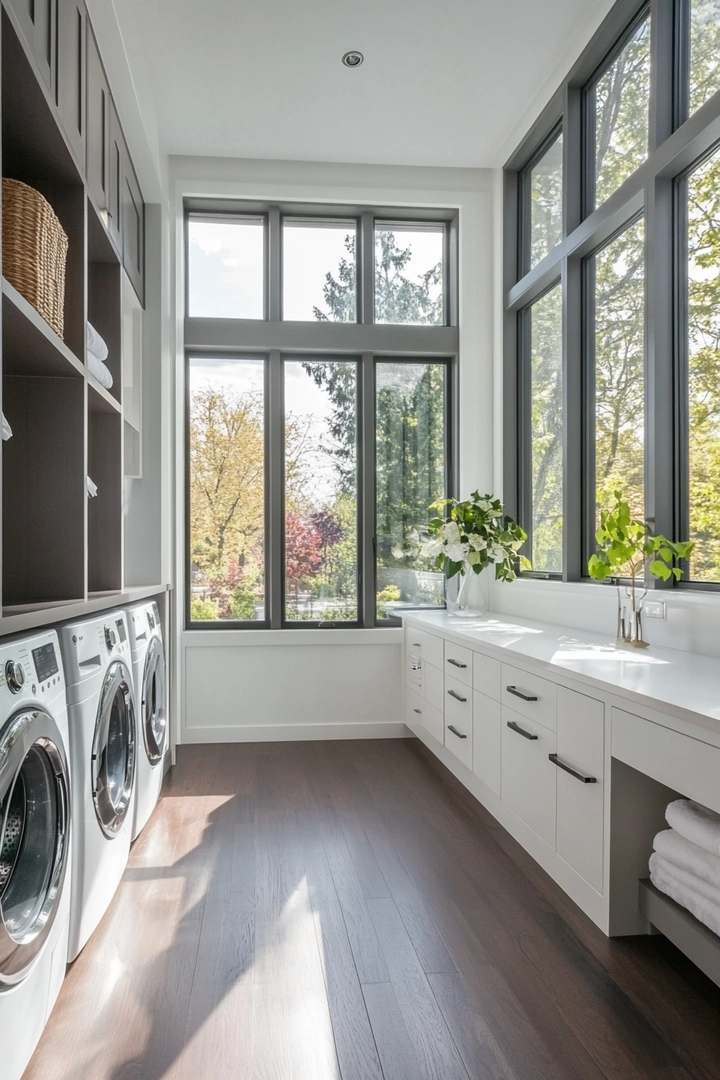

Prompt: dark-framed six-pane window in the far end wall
xmin=186 ymin=203 xmax=458 ymax=629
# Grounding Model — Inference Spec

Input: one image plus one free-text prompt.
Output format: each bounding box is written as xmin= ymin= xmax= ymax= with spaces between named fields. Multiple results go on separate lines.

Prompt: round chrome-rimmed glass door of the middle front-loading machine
xmin=92 ymin=660 xmax=135 ymax=839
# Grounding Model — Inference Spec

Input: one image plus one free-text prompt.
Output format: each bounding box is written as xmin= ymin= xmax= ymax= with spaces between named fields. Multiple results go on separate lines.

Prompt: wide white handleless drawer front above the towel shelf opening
xmin=611 ymin=708 xmax=720 ymax=813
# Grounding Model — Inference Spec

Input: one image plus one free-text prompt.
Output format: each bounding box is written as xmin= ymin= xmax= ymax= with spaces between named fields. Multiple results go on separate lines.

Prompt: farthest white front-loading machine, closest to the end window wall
xmin=127 ymin=602 xmax=168 ymax=839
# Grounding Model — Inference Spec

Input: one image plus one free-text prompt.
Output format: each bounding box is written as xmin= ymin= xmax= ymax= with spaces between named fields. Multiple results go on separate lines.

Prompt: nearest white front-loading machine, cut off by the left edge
xmin=0 ymin=630 xmax=71 ymax=1080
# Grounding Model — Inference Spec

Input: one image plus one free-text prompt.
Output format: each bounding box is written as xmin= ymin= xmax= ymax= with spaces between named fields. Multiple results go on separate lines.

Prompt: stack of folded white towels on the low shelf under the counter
xmin=650 ymin=799 xmax=720 ymax=934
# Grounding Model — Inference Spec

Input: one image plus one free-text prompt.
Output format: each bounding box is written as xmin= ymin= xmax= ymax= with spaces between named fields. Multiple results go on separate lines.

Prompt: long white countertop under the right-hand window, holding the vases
xmin=403 ymin=611 xmax=720 ymax=733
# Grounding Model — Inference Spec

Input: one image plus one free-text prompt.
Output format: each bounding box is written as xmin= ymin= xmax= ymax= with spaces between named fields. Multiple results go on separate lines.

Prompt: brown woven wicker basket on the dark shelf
xmin=2 ymin=177 xmax=68 ymax=337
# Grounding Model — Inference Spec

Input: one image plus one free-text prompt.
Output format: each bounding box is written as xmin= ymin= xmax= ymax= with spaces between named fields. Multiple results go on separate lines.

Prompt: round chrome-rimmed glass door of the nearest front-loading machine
xmin=0 ymin=710 xmax=70 ymax=986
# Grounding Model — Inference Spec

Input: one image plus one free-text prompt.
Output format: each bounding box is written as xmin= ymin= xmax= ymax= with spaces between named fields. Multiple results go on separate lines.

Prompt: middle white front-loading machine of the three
xmin=60 ymin=610 xmax=136 ymax=960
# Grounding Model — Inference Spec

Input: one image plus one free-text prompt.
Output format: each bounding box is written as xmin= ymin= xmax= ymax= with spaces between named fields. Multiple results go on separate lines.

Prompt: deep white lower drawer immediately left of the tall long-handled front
xmin=502 ymin=704 xmax=557 ymax=849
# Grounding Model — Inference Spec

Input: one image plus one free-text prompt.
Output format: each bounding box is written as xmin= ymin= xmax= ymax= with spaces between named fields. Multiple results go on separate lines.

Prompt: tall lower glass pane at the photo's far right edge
xmin=681 ymin=152 xmax=720 ymax=581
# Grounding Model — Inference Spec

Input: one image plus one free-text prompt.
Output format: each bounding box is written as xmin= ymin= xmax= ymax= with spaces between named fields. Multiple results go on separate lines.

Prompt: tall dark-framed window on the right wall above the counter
xmin=504 ymin=0 xmax=720 ymax=590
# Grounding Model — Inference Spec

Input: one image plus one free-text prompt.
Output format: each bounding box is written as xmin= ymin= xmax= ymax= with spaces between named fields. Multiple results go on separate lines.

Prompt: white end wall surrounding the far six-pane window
xmin=167 ymin=158 xmax=494 ymax=742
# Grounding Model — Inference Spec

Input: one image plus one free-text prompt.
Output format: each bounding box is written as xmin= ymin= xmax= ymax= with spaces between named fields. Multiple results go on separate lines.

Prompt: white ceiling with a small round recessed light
xmin=114 ymin=0 xmax=611 ymax=166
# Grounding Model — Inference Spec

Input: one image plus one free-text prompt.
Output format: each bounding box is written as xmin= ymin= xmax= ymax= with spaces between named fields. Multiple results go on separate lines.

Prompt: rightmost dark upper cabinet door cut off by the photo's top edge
xmin=57 ymin=0 xmax=87 ymax=168
